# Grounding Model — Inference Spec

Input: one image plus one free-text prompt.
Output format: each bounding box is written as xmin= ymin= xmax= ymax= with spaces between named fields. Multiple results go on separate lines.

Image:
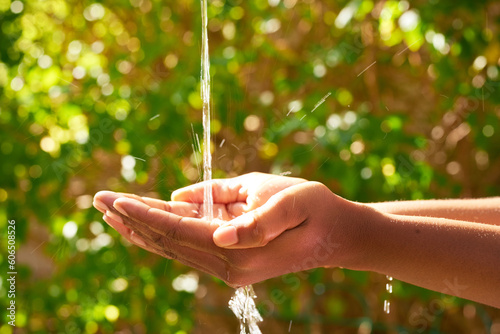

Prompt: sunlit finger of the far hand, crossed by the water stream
xmin=172 ymin=178 xmax=247 ymax=204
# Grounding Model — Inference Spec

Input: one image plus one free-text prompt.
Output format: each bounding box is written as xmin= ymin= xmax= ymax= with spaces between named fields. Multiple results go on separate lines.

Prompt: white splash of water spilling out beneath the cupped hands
xmin=229 ymin=285 xmax=262 ymax=334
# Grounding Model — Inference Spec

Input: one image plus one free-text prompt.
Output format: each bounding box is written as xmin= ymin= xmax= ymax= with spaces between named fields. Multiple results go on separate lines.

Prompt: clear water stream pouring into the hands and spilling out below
xmin=201 ymin=0 xmax=262 ymax=334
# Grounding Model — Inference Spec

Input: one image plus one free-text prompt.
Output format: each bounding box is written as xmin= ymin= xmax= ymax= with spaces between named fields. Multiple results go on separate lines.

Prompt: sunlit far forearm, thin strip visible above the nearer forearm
xmin=367 ymin=197 xmax=500 ymax=226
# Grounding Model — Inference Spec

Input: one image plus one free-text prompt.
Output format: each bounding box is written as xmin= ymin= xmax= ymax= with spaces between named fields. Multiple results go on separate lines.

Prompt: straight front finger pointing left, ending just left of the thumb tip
xmin=114 ymin=198 xmax=218 ymax=253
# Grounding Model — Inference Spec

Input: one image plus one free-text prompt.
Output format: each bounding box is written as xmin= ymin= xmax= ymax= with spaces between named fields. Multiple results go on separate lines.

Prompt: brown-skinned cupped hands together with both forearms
xmin=94 ymin=173 xmax=500 ymax=307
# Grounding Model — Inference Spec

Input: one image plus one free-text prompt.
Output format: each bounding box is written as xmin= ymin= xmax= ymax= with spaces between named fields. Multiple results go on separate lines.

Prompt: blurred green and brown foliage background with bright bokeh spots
xmin=0 ymin=0 xmax=500 ymax=333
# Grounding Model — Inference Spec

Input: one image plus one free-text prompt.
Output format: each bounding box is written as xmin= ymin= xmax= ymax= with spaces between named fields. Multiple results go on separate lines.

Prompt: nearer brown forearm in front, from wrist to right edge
xmin=352 ymin=211 xmax=500 ymax=307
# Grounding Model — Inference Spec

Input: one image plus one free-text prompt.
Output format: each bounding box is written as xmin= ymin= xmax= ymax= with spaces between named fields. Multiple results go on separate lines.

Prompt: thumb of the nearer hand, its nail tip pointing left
xmin=213 ymin=185 xmax=307 ymax=249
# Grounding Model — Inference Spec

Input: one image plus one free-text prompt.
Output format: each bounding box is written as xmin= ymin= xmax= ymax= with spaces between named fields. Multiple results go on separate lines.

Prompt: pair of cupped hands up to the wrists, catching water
xmin=94 ymin=173 xmax=368 ymax=286
